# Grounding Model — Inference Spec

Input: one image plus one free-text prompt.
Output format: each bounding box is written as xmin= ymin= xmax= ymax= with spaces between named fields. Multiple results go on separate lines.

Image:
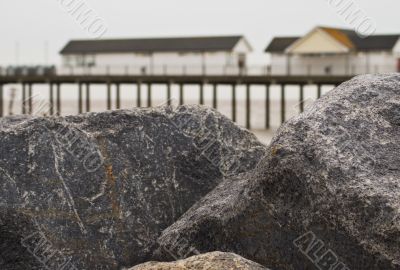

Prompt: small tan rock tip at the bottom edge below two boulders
xmin=130 ymin=252 xmax=267 ymax=270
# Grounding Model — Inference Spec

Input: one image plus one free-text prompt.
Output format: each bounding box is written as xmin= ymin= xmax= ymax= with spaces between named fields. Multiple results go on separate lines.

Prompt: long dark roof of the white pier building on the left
xmin=60 ymin=36 xmax=244 ymax=54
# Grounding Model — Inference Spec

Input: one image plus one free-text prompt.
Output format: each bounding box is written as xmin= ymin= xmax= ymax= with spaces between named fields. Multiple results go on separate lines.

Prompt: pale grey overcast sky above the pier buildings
xmin=0 ymin=0 xmax=400 ymax=65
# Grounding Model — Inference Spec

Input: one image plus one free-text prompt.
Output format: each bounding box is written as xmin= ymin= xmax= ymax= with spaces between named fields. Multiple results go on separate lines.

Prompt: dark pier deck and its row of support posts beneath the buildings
xmin=0 ymin=75 xmax=351 ymax=129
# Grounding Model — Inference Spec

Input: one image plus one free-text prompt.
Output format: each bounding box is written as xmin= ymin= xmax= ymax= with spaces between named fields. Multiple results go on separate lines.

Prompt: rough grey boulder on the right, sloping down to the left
xmin=154 ymin=74 xmax=400 ymax=270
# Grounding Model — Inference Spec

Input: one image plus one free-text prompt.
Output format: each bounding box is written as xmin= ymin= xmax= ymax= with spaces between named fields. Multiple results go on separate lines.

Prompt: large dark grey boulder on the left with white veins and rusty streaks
xmin=0 ymin=106 xmax=266 ymax=270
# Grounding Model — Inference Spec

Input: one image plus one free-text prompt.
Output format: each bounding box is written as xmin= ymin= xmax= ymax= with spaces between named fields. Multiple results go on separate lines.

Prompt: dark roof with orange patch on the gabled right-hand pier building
xmin=265 ymin=27 xmax=400 ymax=53
